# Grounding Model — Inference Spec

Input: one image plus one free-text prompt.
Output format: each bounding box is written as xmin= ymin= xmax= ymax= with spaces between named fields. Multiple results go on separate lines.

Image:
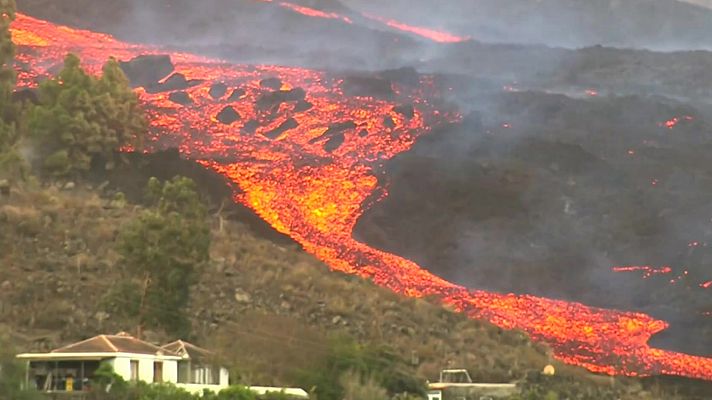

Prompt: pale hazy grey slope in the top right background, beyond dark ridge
xmin=344 ymin=0 xmax=712 ymax=50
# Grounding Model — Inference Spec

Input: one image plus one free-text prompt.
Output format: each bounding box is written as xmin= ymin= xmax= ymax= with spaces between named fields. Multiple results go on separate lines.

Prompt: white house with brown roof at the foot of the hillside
xmin=17 ymin=332 xmax=230 ymax=393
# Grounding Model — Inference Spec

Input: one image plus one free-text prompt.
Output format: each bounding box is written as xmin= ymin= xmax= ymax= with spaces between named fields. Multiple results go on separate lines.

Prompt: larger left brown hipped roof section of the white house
xmin=52 ymin=332 xmax=178 ymax=356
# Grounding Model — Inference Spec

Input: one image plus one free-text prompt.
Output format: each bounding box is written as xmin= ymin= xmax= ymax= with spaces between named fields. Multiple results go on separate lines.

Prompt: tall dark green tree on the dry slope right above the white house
xmin=110 ymin=177 xmax=210 ymax=336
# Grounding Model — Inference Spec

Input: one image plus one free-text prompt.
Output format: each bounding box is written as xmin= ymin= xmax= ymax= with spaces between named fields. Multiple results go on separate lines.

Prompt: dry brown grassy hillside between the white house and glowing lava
xmin=0 ymin=155 xmax=699 ymax=399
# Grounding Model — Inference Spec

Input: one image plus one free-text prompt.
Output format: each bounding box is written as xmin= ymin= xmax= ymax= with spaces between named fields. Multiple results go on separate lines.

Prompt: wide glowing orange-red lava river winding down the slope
xmin=13 ymin=15 xmax=712 ymax=380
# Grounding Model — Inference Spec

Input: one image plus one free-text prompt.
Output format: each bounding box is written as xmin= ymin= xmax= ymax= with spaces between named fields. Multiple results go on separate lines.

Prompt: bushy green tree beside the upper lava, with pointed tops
xmin=27 ymin=54 xmax=147 ymax=176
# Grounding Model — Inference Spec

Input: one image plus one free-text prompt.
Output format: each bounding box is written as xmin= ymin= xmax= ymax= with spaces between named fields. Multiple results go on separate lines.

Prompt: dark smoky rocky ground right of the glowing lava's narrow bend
xmin=356 ymin=86 xmax=712 ymax=355
